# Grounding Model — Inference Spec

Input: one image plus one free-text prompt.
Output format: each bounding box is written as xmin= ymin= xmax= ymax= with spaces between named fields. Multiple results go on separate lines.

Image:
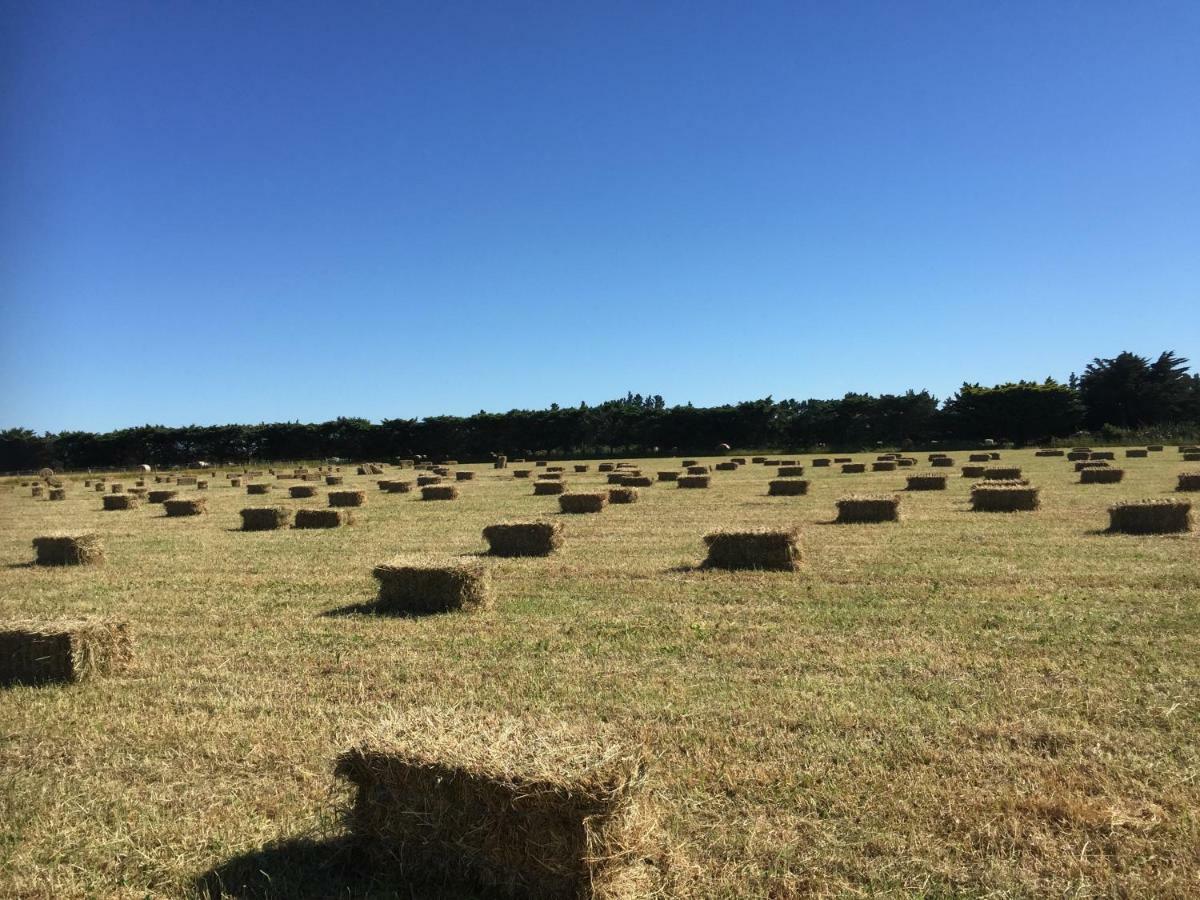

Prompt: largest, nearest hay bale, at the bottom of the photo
xmin=335 ymin=709 xmax=658 ymax=900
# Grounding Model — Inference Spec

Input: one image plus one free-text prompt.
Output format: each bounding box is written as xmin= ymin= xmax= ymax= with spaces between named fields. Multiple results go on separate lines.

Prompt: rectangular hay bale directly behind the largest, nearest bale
xmin=371 ymin=561 xmax=492 ymax=614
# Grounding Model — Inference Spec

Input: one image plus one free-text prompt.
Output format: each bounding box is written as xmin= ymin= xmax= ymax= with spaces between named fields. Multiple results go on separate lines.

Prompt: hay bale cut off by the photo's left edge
xmin=0 ymin=619 xmax=133 ymax=684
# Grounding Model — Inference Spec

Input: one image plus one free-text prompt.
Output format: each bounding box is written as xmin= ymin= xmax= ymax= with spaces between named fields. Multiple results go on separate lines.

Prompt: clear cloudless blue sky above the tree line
xmin=0 ymin=0 xmax=1200 ymax=431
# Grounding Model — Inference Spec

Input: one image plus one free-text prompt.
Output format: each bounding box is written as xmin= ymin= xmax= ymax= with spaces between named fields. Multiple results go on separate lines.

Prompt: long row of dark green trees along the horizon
xmin=0 ymin=352 xmax=1200 ymax=472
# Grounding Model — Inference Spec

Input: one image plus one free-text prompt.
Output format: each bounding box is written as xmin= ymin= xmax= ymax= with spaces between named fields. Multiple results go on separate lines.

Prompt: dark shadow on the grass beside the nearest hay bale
xmin=192 ymin=836 xmax=498 ymax=900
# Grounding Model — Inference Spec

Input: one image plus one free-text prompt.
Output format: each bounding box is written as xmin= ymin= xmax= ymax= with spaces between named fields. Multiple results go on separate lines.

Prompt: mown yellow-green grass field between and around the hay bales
xmin=0 ymin=448 xmax=1200 ymax=900
